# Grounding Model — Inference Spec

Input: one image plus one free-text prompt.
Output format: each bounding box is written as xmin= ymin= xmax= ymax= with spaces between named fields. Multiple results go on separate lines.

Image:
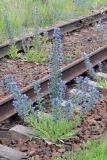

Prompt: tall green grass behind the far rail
xmin=0 ymin=0 xmax=107 ymax=42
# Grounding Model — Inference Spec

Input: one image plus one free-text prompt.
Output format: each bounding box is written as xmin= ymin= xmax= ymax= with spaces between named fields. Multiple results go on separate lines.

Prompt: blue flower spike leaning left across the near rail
xmin=4 ymin=75 xmax=34 ymax=119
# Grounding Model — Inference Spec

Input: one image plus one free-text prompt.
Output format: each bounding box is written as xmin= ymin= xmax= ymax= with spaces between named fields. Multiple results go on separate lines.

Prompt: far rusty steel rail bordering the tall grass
xmin=0 ymin=9 xmax=107 ymax=58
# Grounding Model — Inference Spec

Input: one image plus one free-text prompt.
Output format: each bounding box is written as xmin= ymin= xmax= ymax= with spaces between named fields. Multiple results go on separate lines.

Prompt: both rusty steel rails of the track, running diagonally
xmin=0 ymin=10 xmax=107 ymax=122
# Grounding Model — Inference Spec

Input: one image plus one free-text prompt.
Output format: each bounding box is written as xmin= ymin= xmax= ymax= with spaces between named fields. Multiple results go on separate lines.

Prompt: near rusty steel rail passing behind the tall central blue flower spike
xmin=0 ymin=46 xmax=107 ymax=122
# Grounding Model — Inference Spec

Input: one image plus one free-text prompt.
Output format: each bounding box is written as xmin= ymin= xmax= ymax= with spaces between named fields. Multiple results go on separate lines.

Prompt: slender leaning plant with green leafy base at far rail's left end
xmin=3 ymin=11 xmax=19 ymax=59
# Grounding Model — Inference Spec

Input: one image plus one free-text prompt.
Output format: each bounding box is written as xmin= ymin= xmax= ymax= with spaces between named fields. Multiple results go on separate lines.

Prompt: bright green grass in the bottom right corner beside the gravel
xmin=54 ymin=138 xmax=107 ymax=160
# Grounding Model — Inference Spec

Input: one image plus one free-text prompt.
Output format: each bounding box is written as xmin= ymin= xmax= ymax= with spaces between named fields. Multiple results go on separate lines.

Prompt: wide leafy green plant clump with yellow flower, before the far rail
xmin=22 ymin=32 xmax=49 ymax=64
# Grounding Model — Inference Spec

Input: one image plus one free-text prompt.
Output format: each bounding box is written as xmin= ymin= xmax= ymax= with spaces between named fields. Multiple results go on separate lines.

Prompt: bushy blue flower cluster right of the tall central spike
xmin=70 ymin=76 xmax=99 ymax=116
